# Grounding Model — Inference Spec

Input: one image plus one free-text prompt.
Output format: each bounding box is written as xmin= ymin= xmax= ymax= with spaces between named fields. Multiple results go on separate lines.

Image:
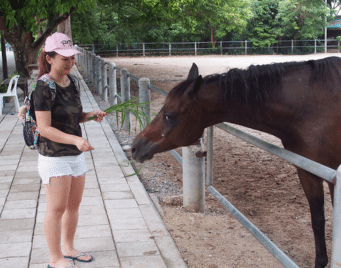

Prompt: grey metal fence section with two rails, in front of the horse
xmin=207 ymin=123 xmax=341 ymax=268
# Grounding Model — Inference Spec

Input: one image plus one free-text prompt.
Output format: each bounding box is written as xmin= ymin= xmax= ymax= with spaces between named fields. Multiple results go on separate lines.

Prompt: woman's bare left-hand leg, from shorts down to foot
xmin=44 ymin=176 xmax=72 ymax=266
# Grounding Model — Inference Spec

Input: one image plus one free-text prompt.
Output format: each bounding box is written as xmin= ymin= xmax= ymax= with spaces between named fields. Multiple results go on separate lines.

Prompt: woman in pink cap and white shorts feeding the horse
xmin=33 ymin=33 xmax=106 ymax=268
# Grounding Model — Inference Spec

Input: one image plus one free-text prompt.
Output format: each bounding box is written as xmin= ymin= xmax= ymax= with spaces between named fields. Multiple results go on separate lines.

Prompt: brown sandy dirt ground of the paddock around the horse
xmin=89 ymin=54 xmax=332 ymax=268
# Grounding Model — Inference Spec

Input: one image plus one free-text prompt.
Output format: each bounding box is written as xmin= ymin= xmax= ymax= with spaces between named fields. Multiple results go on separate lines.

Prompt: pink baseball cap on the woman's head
xmin=45 ymin=32 xmax=80 ymax=57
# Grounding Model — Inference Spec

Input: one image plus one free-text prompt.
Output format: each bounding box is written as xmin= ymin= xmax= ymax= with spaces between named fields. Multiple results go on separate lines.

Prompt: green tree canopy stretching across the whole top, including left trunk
xmin=0 ymin=0 xmax=341 ymax=76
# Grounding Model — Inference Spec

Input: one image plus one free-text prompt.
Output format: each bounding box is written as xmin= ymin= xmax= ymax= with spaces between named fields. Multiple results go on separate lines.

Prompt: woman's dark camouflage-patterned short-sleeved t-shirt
xmin=33 ymin=74 xmax=83 ymax=157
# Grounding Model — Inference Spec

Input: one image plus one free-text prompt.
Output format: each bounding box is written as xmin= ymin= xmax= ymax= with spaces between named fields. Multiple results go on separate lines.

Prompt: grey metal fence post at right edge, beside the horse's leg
xmin=331 ymin=165 xmax=341 ymax=268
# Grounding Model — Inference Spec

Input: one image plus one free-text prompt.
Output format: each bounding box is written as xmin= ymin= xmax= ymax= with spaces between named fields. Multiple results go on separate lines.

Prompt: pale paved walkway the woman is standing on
xmin=0 ymin=68 xmax=187 ymax=268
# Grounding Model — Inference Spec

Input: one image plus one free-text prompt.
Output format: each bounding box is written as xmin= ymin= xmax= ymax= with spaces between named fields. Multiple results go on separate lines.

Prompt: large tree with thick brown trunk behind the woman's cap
xmin=0 ymin=0 xmax=94 ymax=77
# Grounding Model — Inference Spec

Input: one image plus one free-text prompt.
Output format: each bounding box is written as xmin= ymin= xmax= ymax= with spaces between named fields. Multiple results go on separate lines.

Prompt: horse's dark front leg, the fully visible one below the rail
xmin=297 ymin=168 xmax=328 ymax=268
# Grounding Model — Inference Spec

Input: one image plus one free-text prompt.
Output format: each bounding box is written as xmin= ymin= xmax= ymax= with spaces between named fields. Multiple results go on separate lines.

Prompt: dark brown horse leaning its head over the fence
xmin=132 ymin=57 xmax=341 ymax=268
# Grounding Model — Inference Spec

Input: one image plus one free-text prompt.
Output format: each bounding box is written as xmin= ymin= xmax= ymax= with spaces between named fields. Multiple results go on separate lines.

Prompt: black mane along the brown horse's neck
xmin=170 ymin=57 xmax=340 ymax=107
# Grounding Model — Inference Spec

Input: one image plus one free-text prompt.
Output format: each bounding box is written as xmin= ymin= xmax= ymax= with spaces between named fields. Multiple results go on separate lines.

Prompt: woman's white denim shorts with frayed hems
xmin=38 ymin=153 xmax=88 ymax=184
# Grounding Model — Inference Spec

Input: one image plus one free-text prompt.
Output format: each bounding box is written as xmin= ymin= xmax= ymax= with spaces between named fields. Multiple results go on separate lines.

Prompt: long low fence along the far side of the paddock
xmin=79 ymin=39 xmax=340 ymax=57
